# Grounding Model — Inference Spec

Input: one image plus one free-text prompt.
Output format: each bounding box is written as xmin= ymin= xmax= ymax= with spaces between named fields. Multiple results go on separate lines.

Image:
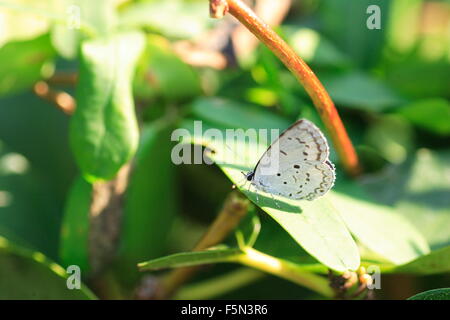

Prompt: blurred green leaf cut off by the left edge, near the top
xmin=0 ymin=34 xmax=55 ymax=95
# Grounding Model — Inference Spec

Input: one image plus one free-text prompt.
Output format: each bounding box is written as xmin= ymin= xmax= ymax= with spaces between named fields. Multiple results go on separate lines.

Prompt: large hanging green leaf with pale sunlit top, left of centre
xmin=70 ymin=33 xmax=145 ymax=181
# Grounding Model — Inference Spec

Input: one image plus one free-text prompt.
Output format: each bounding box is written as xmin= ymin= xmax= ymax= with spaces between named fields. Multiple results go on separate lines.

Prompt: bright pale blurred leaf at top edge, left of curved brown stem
xmin=120 ymin=0 xmax=212 ymax=38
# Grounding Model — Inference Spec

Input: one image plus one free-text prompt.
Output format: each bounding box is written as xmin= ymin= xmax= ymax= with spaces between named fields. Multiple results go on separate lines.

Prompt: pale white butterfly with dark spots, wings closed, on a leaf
xmin=244 ymin=119 xmax=335 ymax=200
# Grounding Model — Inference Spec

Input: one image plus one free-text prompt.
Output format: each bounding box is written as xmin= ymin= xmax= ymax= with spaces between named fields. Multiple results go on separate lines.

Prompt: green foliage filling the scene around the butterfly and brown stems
xmin=0 ymin=0 xmax=450 ymax=299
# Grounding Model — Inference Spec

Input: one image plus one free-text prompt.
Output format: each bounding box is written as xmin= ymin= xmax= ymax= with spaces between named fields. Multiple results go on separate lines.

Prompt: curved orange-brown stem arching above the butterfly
xmin=212 ymin=0 xmax=360 ymax=175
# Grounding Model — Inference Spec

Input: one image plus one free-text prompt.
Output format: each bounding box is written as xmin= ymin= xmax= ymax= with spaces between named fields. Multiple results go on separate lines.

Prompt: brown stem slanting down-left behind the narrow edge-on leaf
xmin=156 ymin=192 xmax=248 ymax=299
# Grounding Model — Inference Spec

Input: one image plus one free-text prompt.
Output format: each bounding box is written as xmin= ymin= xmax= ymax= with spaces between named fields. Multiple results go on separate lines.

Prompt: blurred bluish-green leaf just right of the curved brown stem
xmin=322 ymin=72 xmax=405 ymax=112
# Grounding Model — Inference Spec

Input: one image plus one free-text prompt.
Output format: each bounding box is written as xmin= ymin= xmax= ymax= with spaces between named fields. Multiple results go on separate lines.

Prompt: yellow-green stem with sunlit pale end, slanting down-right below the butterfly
xmin=238 ymin=247 xmax=334 ymax=298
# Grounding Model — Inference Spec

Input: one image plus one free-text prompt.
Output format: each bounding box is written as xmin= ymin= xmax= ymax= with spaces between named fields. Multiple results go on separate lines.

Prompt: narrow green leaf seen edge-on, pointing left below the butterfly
xmin=138 ymin=247 xmax=243 ymax=271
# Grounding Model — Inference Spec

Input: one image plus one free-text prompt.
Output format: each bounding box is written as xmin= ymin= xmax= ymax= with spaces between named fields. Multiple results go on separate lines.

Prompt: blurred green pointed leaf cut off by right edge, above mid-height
xmin=396 ymin=98 xmax=450 ymax=135
